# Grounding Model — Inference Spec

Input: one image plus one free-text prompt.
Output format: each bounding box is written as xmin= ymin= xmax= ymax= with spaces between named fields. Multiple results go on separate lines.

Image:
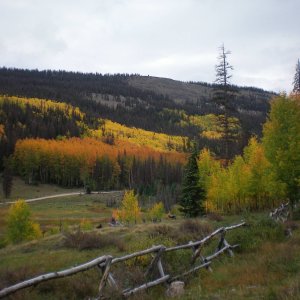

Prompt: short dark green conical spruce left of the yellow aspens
xmin=180 ymin=149 xmax=205 ymax=217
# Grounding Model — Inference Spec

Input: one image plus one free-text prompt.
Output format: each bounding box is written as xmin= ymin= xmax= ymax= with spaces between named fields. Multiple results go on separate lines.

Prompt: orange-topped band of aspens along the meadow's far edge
xmin=12 ymin=138 xmax=185 ymax=194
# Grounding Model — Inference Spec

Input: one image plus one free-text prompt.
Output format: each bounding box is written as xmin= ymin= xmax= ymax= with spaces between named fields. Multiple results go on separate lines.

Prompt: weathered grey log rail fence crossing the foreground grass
xmin=0 ymin=222 xmax=246 ymax=299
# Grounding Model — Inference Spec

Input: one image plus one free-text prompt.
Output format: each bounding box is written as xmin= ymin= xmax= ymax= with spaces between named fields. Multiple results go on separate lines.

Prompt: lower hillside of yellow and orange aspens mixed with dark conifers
xmin=0 ymin=96 xmax=189 ymax=206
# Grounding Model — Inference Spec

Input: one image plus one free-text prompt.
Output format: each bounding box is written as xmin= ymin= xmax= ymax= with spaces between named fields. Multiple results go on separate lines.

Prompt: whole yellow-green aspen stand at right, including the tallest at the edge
xmin=198 ymin=95 xmax=300 ymax=213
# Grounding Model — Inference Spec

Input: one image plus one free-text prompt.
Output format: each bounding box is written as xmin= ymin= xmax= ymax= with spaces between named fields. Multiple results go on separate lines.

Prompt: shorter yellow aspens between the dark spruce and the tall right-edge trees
xmin=199 ymin=138 xmax=285 ymax=213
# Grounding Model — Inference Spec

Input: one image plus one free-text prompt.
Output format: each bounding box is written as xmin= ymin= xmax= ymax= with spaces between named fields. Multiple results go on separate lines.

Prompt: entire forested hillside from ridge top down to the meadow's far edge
xmin=0 ymin=68 xmax=274 ymax=206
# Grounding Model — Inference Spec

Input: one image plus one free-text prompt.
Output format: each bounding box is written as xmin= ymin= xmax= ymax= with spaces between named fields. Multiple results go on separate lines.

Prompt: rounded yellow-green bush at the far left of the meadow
xmin=7 ymin=200 xmax=42 ymax=243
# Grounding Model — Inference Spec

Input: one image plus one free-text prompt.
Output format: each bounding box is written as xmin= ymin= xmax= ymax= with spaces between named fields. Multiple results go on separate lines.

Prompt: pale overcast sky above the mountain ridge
xmin=0 ymin=0 xmax=300 ymax=92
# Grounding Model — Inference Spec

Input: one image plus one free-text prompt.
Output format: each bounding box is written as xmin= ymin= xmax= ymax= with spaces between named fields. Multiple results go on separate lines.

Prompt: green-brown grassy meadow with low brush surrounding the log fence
xmin=0 ymin=182 xmax=300 ymax=300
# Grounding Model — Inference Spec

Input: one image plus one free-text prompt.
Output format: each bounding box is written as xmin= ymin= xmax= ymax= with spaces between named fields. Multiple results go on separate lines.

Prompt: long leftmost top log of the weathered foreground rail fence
xmin=0 ymin=256 xmax=108 ymax=298
